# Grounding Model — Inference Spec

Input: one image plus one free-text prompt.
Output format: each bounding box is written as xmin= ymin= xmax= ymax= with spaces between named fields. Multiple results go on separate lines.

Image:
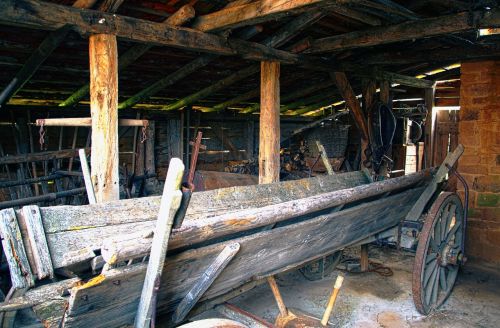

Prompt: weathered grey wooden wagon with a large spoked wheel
xmin=0 ymin=146 xmax=465 ymax=327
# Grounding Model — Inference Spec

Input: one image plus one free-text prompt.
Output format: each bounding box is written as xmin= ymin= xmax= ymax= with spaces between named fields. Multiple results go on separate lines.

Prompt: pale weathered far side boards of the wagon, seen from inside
xmin=17 ymin=171 xmax=369 ymax=269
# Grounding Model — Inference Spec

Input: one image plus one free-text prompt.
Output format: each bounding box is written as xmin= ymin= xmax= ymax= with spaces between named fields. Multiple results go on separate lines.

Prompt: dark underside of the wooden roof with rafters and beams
xmin=0 ymin=0 xmax=500 ymax=115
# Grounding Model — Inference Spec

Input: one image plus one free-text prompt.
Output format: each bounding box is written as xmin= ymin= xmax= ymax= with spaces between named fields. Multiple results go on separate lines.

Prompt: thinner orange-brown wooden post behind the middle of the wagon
xmin=259 ymin=61 xmax=280 ymax=183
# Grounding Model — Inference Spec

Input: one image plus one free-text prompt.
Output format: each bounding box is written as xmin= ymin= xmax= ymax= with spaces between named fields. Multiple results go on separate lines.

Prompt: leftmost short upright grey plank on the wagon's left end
xmin=0 ymin=208 xmax=35 ymax=289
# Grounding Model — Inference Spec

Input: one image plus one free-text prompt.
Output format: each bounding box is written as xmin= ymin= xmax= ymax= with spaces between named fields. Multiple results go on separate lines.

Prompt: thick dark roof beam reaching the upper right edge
xmin=306 ymin=8 xmax=500 ymax=53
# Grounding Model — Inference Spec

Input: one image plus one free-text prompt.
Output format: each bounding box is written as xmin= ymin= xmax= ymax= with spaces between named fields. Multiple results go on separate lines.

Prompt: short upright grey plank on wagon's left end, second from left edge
xmin=22 ymin=205 xmax=54 ymax=279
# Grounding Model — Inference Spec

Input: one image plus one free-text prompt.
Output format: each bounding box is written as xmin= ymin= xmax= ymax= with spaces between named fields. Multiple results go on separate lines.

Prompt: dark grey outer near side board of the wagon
xmin=56 ymin=188 xmax=423 ymax=327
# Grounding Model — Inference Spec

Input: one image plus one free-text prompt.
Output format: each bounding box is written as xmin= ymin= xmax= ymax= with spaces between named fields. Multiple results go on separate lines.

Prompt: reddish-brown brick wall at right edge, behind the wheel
xmin=458 ymin=61 xmax=500 ymax=263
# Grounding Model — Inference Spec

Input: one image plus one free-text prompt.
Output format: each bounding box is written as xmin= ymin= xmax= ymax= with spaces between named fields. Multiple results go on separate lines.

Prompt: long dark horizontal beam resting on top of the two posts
xmin=0 ymin=0 xmax=300 ymax=64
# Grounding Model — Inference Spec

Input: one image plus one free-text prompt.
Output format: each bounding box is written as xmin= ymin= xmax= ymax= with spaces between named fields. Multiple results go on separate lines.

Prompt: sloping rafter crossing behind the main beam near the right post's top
xmin=157 ymin=12 xmax=324 ymax=111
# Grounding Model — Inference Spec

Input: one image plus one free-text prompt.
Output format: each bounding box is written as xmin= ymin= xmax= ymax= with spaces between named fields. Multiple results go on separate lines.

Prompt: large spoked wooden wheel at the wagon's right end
xmin=412 ymin=192 xmax=464 ymax=315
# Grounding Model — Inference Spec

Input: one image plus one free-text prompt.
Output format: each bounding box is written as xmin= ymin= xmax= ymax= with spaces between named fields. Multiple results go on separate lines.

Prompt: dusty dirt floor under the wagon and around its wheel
xmin=198 ymin=246 xmax=500 ymax=328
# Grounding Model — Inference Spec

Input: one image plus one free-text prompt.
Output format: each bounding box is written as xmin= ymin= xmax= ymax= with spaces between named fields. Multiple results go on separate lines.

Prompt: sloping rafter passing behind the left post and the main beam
xmin=59 ymin=5 xmax=195 ymax=107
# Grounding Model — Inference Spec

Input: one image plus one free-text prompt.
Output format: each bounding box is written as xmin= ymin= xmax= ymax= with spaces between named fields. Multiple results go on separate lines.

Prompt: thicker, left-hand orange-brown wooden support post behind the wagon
xmin=89 ymin=34 xmax=120 ymax=203
